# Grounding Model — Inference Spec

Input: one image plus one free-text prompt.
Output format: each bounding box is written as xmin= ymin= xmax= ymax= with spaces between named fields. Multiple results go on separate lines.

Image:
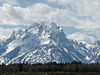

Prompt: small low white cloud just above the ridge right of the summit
xmin=67 ymin=32 xmax=96 ymax=44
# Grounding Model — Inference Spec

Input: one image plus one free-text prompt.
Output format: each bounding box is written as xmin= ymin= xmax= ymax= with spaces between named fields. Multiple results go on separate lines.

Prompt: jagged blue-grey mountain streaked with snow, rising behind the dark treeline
xmin=0 ymin=23 xmax=99 ymax=64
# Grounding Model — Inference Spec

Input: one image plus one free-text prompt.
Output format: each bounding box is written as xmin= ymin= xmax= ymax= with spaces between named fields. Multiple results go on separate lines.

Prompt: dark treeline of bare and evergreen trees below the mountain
xmin=0 ymin=62 xmax=100 ymax=72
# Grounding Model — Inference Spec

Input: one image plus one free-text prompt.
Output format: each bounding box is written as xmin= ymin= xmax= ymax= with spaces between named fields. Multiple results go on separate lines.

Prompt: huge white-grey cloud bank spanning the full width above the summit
xmin=0 ymin=0 xmax=100 ymax=41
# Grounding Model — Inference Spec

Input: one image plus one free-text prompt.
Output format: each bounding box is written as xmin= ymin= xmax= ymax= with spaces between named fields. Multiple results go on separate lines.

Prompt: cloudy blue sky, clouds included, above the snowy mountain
xmin=0 ymin=0 xmax=100 ymax=43
